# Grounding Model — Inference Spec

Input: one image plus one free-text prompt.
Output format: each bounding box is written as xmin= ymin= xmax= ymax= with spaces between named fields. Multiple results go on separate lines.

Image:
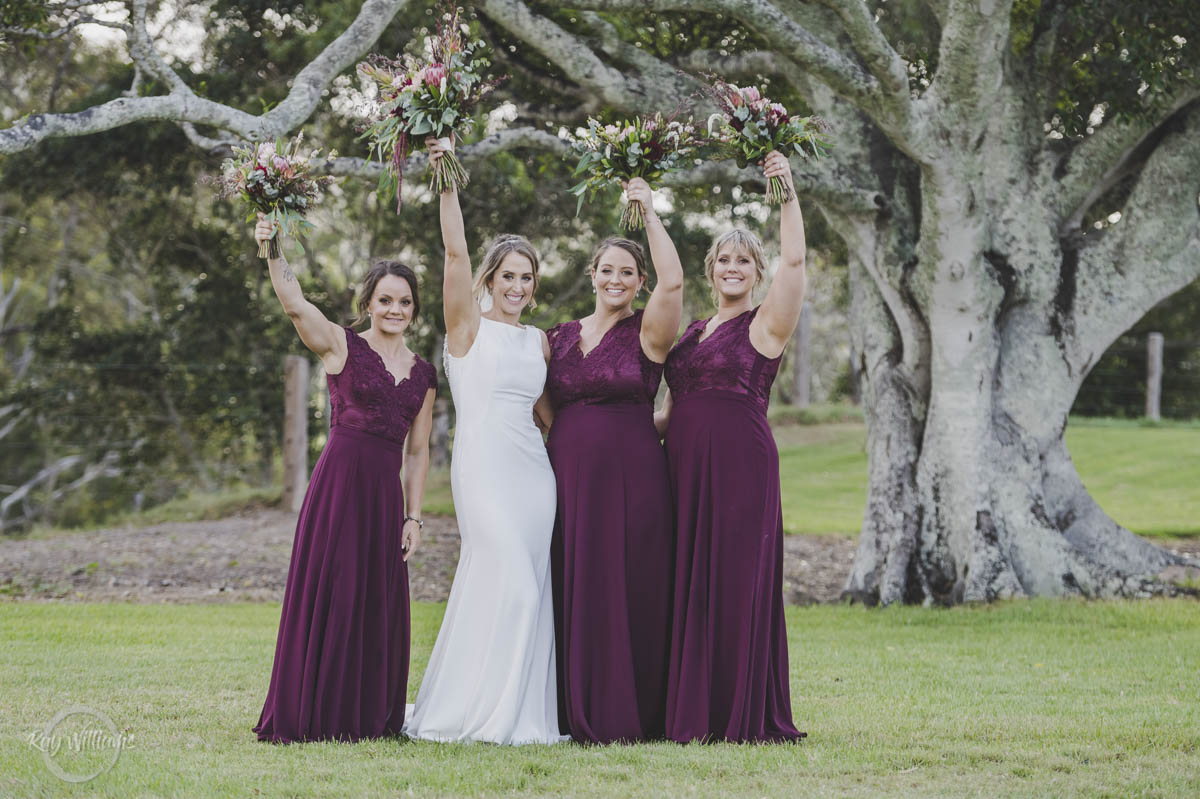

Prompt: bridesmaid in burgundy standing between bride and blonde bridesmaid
xmin=546 ymin=178 xmax=683 ymax=744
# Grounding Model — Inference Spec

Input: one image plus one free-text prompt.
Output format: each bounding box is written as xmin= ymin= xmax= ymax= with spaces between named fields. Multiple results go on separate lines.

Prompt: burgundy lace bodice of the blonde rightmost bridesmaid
xmin=666 ymin=303 xmax=782 ymax=411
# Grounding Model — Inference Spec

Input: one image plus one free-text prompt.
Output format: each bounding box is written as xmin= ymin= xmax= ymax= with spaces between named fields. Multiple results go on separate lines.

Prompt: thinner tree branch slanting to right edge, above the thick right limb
xmin=1049 ymin=83 xmax=1200 ymax=236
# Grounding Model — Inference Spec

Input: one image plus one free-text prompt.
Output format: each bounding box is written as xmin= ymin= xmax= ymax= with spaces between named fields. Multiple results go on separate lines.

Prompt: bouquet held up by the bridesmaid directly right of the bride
xmin=570 ymin=114 xmax=704 ymax=230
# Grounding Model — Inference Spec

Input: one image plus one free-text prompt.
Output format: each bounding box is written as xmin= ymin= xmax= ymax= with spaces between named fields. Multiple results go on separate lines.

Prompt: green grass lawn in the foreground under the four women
xmin=0 ymin=601 xmax=1200 ymax=799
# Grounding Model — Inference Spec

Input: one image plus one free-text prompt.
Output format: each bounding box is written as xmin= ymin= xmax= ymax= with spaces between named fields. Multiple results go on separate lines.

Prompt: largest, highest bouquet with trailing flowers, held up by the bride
xmin=359 ymin=6 xmax=502 ymax=214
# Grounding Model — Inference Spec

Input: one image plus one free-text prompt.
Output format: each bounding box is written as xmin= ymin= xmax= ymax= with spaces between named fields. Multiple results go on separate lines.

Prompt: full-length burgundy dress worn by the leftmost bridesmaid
xmin=254 ymin=328 xmax=437 ymax=743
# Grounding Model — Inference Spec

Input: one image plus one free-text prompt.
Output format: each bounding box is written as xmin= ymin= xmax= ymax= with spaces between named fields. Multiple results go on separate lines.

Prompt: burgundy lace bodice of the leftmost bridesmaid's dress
xmin=325 ymin=328 xmax=438 ymax=443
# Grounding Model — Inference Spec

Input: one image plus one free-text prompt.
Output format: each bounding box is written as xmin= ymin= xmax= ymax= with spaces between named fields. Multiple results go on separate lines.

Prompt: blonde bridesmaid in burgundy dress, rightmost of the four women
xmin=655 ymin=151 xmax=805 ymax=741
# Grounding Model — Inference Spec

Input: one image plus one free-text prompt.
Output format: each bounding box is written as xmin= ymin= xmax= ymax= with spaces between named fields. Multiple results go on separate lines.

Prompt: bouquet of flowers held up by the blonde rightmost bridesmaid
xmin=708 ymin=80 xmax=830 ymax=205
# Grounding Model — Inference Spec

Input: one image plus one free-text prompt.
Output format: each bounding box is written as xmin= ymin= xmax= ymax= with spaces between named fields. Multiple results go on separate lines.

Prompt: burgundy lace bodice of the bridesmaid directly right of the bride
xmin=546 ymin=311 xmax=664 ymax=408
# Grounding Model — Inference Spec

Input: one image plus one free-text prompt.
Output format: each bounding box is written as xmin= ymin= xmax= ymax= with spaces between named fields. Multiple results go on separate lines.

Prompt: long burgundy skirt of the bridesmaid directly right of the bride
xmin=548 ymin=404 xmax=674 ymax=744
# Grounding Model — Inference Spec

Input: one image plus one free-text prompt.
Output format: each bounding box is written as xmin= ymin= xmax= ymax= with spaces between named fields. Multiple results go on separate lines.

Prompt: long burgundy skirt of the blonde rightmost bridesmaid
xmin=666 ymin=390 xmax=803 ymax=741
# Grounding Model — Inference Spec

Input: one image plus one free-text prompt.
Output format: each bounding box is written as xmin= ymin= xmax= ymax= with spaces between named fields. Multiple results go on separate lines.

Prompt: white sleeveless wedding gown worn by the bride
xmin=404 ymin=318 xmax=568 ymax=744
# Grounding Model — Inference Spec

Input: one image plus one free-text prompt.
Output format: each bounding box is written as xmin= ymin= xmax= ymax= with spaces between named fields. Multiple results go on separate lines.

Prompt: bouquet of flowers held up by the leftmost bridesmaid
xmin=218 ymin=133 xmax=336 ymax=258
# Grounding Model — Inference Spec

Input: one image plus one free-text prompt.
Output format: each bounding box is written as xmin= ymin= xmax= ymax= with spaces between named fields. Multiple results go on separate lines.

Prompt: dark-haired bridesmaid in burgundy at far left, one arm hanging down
xmin=254 ymin=215 xmax=437 ymax=743
